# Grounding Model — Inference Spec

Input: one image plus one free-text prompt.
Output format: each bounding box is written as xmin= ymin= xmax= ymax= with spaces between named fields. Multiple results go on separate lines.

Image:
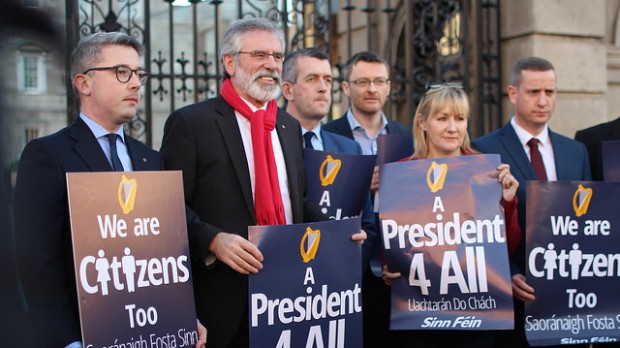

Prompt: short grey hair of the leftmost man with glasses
xmin=71 ymin=32 xmax=144 ymax=77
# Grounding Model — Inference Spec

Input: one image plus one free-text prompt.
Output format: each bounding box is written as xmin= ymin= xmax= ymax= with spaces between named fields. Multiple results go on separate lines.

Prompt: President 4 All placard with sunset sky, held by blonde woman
xmin=379 ymin=155 xmax=514 ymax=330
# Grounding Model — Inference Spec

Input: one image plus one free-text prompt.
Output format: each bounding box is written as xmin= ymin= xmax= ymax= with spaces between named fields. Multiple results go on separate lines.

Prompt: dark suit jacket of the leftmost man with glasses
xmin=14 ymin=117 xmax=163 ymax=348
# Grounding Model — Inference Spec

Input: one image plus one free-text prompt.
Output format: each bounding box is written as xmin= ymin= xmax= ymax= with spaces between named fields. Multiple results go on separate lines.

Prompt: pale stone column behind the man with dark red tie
xmin=501 ymin=0 xmax=604 ymax=138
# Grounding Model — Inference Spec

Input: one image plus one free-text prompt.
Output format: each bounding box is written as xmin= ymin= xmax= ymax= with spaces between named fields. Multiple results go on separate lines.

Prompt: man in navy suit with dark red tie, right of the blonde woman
xmin=472 ymin=57 xmax=591 ymax=347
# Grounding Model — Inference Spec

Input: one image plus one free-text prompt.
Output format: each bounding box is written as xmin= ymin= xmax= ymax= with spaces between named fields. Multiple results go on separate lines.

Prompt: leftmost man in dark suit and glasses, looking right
xmin=14 ymin=33 xmax=204 ymax=348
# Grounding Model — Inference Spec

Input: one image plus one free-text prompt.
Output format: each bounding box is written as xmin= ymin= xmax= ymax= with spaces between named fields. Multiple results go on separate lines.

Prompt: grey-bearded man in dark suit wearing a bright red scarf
xmin=161 ymin=18 xmax=365 ymax=348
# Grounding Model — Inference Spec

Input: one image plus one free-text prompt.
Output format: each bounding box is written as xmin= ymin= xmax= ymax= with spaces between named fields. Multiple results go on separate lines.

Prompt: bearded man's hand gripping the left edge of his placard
xmin=209 ymin=232 xmax=263 ymax=274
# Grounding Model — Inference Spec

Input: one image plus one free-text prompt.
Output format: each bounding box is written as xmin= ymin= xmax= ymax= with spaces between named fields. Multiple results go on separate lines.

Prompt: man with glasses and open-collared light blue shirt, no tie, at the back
xmin=322 ymin=51 xmax=411 ymax=347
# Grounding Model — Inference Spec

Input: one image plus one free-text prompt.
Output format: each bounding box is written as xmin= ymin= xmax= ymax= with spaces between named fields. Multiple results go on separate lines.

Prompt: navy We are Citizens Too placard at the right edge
xmin=525 ymin=181 xmax=620 ymax=346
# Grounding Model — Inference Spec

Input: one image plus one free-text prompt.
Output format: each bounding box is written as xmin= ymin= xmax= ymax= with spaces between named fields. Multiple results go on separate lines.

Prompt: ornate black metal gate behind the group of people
xmin=66 ymin=0 xmax=501 ymax=147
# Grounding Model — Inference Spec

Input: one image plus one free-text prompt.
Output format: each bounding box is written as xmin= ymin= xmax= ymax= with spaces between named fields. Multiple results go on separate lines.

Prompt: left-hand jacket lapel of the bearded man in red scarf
xmin=215 ymin=97 xmax=256 ymax=219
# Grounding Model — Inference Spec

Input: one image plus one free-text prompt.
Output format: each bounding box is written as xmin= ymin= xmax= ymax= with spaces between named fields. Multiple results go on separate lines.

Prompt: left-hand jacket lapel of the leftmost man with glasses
xmin=69 ymin=117 xmax=112 ymax=172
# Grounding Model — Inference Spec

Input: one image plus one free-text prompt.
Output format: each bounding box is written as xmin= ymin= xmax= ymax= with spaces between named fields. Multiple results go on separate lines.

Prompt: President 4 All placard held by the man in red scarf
xmin=248 ymin=218 xmax=362 ymax=348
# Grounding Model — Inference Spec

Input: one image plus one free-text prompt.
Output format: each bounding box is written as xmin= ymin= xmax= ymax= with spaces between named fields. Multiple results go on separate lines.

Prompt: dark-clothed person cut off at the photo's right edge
xmin=575 ymin=117 xmax=620 ymax=181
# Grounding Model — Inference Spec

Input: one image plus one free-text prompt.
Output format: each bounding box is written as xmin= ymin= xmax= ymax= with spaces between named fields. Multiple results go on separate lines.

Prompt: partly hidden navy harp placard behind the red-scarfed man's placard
xmin=304 ymin=150 xmax=376 ymax=220
